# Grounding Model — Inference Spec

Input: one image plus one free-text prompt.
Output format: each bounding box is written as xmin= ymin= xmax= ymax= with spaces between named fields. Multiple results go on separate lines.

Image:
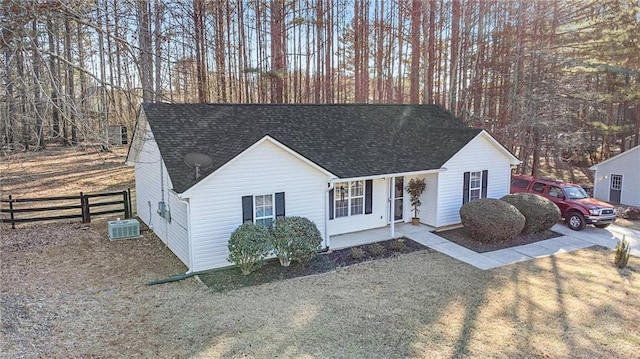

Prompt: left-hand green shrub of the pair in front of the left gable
xmin=227 ymin=223 xmax=271 ymax=275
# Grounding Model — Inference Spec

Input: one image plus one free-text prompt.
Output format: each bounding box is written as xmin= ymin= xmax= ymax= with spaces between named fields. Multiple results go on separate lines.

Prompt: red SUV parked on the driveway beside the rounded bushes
xmin=511 ymin=175 xmax=616 ymax=231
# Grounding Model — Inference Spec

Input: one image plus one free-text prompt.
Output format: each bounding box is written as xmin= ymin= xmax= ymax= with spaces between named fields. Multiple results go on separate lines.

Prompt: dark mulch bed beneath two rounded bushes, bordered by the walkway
xmin=434 ymin=227 xmax=562 ymax=253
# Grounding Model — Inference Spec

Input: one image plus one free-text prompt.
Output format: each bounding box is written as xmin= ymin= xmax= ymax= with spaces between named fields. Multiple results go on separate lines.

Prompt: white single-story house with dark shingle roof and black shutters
xmin=127 ymin=104 xmax=520 ymax=271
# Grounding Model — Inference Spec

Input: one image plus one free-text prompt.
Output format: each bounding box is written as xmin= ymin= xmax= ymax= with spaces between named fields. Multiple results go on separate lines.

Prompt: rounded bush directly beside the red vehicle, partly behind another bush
xmin=501 ymin=193 xmax=560 ymax=234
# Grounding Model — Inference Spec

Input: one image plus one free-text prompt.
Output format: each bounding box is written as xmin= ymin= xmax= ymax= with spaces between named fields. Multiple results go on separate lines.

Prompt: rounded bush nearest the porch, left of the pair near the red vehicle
xmin=460 ymin=198 xmax=525 ymax=243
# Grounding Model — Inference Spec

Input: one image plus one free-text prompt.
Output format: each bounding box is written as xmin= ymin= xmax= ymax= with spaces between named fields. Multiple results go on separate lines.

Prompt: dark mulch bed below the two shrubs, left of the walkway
xmin=198 ymin=238 xmax=430 ymax=292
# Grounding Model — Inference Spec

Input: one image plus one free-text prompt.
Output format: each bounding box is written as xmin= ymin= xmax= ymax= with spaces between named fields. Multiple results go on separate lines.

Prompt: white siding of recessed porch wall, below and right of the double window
xmin=329 ymin=178 xmax=390 ymax=236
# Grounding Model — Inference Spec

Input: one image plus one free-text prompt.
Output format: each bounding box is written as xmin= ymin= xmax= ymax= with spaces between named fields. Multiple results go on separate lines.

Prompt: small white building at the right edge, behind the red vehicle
xmin=589 ymin=146 xmax=640 ymax=207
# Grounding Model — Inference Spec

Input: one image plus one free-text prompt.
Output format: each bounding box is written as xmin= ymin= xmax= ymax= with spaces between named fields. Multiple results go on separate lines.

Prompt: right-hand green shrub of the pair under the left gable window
xmin=271 ymin=217 xmax=322 ymax=267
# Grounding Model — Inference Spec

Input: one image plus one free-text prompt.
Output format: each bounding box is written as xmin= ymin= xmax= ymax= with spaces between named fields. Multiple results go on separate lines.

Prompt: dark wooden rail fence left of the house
xmin=0 ymin=190 xmax=132 ymax=229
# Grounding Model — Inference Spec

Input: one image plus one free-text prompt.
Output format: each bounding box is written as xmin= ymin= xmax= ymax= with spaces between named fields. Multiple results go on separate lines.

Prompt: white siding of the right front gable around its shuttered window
xmin=435 ymin=134 xmax=511 ymax=227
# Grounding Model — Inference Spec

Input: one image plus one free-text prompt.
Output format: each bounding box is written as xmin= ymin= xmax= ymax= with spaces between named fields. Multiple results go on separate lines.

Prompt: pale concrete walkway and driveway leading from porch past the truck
xmin=402 ymin=224 xmax=640 ymax=269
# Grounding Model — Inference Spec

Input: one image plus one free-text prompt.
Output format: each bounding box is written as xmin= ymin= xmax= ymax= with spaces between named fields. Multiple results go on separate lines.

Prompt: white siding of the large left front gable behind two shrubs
xmin=182 ymin=141 xmax=328 ymax=271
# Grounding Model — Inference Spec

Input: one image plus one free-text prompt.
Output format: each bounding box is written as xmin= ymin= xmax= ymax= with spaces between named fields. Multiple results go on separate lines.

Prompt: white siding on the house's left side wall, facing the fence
xmin=135 ymin=128 xmax=189 ymax=267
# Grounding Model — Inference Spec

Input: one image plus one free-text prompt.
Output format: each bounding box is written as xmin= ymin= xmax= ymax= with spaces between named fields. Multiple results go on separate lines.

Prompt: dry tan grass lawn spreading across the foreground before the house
xmin=0 ymin=146 xmax=640 ymax=358
